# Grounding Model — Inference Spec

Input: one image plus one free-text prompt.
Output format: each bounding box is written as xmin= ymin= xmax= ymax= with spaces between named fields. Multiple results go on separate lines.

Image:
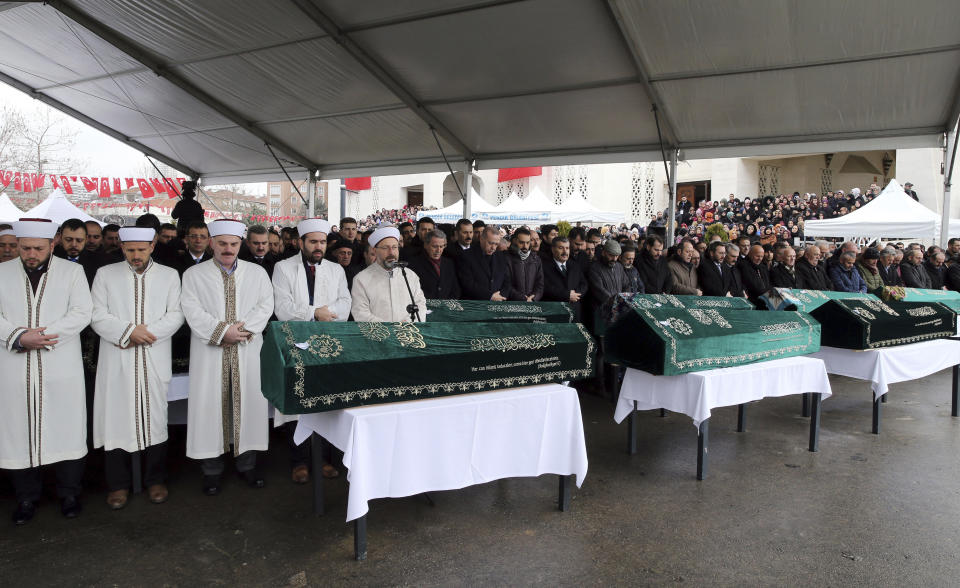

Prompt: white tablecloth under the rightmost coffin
xmin=810 ymin=339 xmax=960 ymax=400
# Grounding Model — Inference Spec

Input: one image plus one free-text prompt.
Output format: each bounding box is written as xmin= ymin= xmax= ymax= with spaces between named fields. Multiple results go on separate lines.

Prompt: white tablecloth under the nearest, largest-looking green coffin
xmin=294 ymin=384 xmax=587 ymax=521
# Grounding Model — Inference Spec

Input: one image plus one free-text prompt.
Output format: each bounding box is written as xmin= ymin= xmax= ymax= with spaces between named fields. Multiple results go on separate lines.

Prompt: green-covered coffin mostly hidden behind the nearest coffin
xmin=427 ymin=299 xmax=573 ymax=323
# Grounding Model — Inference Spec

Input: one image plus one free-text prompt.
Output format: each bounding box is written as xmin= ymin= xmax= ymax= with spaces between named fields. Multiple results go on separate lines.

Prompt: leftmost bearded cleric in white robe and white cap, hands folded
xmin=0 ymin=219 xmax=91 ymax=525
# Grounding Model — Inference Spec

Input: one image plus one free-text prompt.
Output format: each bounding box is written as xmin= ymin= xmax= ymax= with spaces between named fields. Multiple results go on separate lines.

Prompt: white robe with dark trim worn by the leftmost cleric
xmin=0 ymin=255 xmax=91 ymax=470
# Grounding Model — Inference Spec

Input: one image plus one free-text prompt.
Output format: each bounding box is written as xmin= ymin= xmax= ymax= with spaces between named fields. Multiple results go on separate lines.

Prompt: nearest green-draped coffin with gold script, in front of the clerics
xmin=260 ymin=322 xmax=595 ymax=414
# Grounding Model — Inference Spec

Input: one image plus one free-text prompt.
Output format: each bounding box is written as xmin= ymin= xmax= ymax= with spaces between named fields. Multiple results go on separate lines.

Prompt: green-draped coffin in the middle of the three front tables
xmin=605 ymin=308 xmax=820 ymax=375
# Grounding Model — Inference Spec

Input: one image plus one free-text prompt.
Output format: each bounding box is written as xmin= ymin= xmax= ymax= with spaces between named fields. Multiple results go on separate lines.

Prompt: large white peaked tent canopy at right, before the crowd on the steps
xmin=803 ymin=180 xmax=940 ymax=239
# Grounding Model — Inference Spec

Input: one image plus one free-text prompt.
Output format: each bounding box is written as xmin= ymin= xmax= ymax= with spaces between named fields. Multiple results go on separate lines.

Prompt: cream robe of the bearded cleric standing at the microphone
xmin=351 ymin=263 xmax=427 ymax=323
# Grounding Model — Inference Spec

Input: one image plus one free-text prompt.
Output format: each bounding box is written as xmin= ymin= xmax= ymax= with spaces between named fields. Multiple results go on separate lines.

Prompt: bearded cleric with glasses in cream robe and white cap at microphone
xmin=352 ymin=227 xmax=427 ymax=322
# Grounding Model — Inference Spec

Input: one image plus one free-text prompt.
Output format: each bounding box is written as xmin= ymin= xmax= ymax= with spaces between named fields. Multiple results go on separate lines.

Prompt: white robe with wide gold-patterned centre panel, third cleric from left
xmin=180 ymin=259 xmax=273 ymax=459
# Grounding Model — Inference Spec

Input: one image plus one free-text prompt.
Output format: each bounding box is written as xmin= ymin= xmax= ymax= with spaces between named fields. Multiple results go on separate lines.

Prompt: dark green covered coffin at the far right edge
xmin=810 ymin=299 xmax=957 ymax=349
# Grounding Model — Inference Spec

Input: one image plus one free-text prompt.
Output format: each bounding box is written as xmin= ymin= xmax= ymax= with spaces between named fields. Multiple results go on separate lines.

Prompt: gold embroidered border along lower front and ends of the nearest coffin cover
xmin=280 ymin=323 xmax=596 ymax=408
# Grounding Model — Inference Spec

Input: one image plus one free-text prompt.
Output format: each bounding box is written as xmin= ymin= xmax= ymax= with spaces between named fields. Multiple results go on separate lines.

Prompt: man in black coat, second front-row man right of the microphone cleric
xmin=457 ymin=225 xmax=510 ymax=301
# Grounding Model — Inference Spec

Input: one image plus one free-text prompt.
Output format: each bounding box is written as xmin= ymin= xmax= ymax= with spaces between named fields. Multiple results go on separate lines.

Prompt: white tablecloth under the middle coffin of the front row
xmin=613 ymin=357 xmax=832 ymax=427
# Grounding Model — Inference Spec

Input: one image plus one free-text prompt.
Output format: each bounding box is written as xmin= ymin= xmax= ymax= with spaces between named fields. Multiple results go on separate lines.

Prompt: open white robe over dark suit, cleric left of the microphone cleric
xmin=273 ymin=255 xmax=351 ymax=427
